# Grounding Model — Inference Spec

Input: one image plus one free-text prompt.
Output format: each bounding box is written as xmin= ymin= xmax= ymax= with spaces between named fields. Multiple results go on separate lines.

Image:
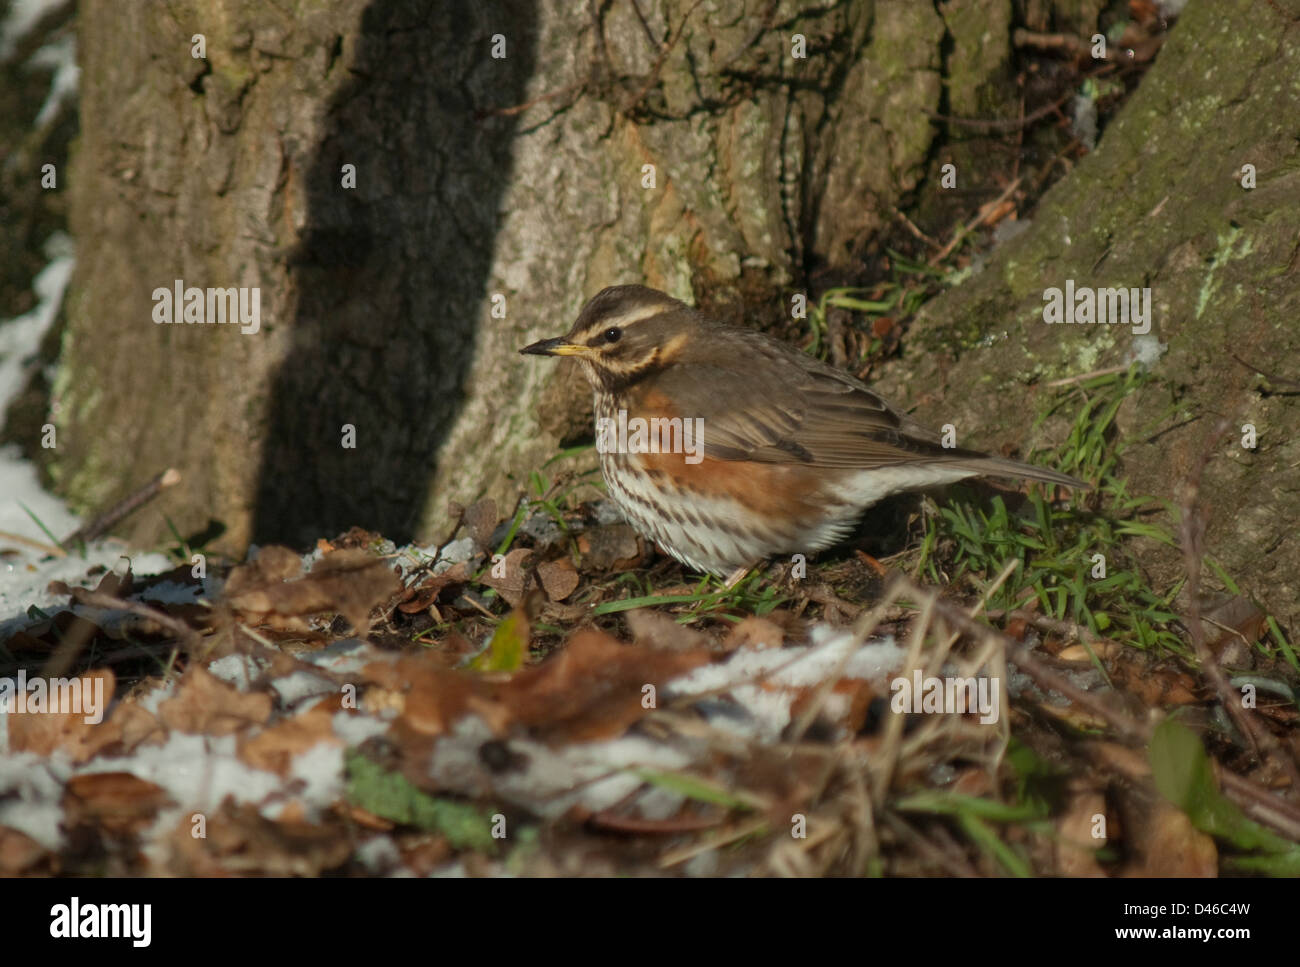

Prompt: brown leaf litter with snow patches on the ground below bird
xmin=0 ymin=491 xmax=1300 ymax=876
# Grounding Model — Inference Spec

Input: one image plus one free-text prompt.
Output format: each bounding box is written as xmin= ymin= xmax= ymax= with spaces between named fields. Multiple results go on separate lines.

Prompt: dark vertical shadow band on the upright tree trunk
xmin=252 ymin=0 xmax=536 ymax=545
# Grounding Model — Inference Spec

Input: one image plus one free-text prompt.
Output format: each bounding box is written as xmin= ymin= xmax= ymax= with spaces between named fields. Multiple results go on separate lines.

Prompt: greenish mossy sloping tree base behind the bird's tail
xmin=879 ymin=0 xmax=1300 ymax=628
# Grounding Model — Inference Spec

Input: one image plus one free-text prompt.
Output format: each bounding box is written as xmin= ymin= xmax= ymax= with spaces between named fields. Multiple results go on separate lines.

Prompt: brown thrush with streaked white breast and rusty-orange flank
xmin=520 ymin=286 xmax=1088 ymax=574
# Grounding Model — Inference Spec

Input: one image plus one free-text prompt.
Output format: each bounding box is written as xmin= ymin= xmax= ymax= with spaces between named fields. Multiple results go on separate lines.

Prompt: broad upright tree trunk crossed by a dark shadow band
xmin=53 ymin=0 xmax=1010 ymax=548
